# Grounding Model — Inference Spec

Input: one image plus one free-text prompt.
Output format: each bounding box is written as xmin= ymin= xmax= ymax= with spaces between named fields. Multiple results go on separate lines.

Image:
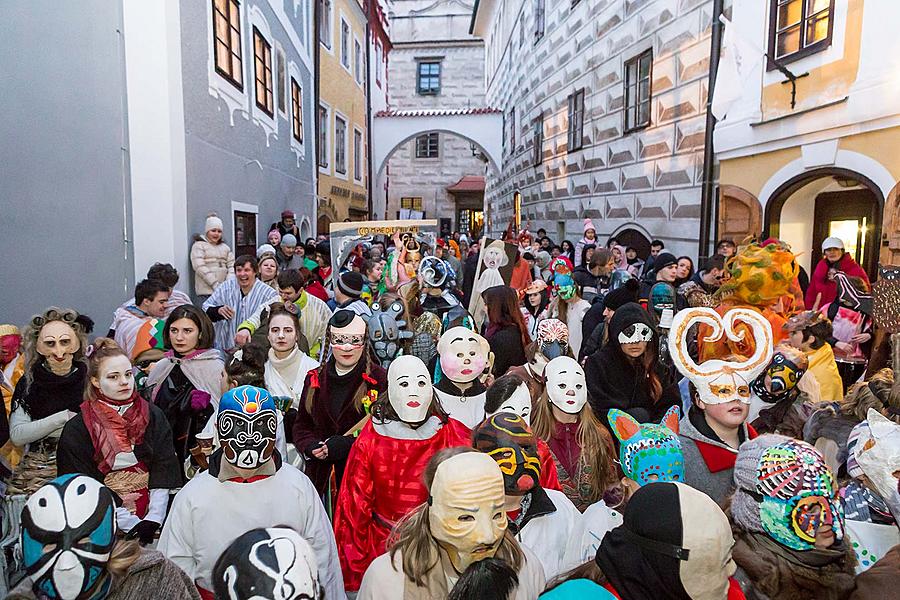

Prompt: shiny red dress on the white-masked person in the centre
xmin=334 ymin=419 xmax=471 ymax=592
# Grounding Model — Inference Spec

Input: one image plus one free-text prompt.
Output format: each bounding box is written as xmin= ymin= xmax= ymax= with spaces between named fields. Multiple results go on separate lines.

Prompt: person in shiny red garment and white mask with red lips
xmin=334 ymin=356 xmax=469 ymax=591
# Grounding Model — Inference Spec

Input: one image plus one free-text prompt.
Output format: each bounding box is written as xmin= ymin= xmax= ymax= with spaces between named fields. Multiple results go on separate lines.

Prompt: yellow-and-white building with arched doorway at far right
xmin=715 ymin=0 xmax=900 ymax=277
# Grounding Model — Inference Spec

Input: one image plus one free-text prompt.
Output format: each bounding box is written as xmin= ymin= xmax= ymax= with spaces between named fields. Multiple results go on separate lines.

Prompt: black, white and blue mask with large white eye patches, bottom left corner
xmin=22 ymin=473 xmax=116 ymax=600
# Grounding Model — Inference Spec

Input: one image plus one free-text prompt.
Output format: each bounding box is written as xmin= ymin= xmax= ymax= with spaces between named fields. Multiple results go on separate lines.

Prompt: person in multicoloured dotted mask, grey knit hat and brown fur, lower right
xmin=729 ymin=434 xmax=855 ymax=600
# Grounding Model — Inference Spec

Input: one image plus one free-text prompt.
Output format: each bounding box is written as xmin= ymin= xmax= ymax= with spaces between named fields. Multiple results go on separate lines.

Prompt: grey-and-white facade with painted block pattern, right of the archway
xmin=471 ymin=0 xmax=712 ymax=256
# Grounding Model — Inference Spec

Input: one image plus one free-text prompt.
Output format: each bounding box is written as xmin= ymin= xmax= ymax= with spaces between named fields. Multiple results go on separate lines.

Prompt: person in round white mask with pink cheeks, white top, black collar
xmin=434 ymin=327 xmax=493 ymax=429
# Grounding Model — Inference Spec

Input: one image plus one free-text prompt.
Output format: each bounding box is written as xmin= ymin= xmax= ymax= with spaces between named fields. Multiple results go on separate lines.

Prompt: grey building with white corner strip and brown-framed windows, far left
xmin=0 ymin=0 xmax=316 ymax=331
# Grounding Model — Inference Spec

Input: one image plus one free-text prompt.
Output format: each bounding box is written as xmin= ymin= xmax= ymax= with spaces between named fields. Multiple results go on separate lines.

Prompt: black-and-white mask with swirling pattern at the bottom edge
xmin=213 ymin=527 xmax=322 ymax=600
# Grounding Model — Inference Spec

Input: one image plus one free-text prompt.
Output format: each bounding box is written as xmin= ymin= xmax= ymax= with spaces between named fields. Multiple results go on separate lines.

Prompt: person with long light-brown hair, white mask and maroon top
xmin=532 ymin=356 xmax=615 ymax=512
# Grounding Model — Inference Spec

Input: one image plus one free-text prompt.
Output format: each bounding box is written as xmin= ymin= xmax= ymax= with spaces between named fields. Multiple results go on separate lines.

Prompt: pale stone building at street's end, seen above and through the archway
xmin=382 ymin=0 xmax=485 ymax=236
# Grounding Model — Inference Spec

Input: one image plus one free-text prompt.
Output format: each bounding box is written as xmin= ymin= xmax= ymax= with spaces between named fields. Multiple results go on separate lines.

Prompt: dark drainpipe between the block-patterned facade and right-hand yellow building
xmin=697 ymin=0 xmax=725 ymax=260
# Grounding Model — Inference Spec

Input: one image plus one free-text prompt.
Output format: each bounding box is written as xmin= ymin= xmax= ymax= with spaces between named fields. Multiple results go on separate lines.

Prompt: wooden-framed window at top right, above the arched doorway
xmin=769 ymin=0 xmax=834 ymax=64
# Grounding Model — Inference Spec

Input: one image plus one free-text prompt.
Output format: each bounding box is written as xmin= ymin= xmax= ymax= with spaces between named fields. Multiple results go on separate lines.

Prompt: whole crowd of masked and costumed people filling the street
xmin=0 ymin=211 xmax=900 ymax=600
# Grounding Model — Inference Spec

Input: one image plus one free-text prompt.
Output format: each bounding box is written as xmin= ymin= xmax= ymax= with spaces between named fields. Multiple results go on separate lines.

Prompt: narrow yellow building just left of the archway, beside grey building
xmin=316 ymin=0 xmax=369 ymax=233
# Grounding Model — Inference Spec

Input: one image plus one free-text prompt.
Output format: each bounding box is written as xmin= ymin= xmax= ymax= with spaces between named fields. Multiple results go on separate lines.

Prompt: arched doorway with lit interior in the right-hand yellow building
xmin=764 ymin=168 xmax=884 ymax=279
